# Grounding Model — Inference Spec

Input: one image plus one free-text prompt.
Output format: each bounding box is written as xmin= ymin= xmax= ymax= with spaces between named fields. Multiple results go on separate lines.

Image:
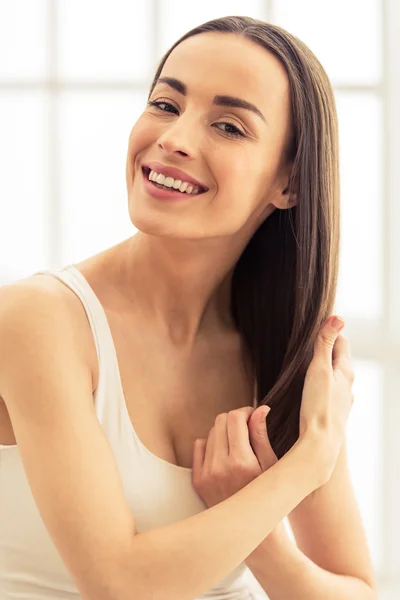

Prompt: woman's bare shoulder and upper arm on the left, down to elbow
xmin=0 ymin=275 xmax=140 ymax=598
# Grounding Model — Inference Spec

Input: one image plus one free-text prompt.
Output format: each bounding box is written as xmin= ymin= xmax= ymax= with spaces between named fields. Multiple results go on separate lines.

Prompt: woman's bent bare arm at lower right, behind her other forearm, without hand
xmin=242 ymin=442 xmax=377 ymax=600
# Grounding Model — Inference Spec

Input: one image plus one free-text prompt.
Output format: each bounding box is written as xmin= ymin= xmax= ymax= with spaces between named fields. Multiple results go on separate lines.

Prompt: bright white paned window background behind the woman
xmin=0 ymin=0 xmax=400 ymax=600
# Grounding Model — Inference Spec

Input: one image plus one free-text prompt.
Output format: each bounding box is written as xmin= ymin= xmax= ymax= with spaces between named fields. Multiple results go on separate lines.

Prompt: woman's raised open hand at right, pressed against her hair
xmin=299 ymin=318 xmax=354 ymax=481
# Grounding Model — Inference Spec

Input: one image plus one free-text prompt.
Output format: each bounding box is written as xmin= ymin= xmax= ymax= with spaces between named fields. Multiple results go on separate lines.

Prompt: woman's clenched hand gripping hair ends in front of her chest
xmin=192 ymin=405 xmax=278 ymax=508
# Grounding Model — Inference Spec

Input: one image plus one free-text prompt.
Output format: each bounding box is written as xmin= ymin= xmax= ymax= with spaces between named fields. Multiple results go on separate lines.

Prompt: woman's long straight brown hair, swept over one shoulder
xmin=149 ymin=16 xmax=340 ymax=458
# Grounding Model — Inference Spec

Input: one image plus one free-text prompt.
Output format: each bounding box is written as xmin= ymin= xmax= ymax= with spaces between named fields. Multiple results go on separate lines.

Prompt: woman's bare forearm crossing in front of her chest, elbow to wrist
xmin=129 ymin=438 xmax=321 ymax=600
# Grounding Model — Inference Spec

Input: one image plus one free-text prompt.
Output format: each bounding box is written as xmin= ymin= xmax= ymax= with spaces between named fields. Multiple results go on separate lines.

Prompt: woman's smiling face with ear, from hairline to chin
xmin=126 ymin=32 xmax=291 ymax=239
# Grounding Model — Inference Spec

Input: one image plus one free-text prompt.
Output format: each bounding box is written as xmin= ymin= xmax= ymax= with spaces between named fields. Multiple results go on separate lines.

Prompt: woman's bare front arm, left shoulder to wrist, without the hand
xmin=0 ymin=282 xmax=326 ymax=600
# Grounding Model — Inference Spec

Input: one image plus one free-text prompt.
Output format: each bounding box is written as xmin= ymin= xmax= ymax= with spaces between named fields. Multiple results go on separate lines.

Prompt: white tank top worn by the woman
xmin=0 ymin=265 xmax=260 ymax=600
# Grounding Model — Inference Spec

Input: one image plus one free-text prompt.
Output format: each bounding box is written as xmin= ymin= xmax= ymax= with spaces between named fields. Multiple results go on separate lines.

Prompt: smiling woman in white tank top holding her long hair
xmin=0 ymin=12 xmax=376 ymax=600
